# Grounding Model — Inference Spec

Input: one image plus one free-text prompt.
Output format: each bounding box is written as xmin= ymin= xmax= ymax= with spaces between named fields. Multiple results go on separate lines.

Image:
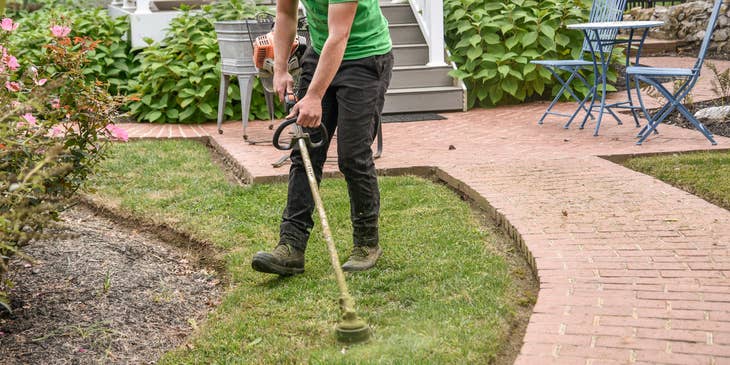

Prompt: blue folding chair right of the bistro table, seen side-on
xmin=626 ymin=0 xmax=723 ymax=145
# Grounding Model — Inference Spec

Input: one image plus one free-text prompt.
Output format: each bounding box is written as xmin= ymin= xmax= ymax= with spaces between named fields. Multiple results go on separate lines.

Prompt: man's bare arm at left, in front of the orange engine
xmin=274 ymin=0 xmax=299 ymax=101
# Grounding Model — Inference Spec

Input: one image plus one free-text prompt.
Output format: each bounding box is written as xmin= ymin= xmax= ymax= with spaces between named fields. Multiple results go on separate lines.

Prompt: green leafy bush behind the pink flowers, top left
xmin=8 ymin=4 xmax=139 ymax=94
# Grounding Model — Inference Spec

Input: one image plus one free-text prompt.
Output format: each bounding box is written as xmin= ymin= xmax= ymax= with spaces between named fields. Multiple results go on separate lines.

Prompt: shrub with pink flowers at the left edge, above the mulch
xmin=0 ymin=18 xmax=127 ymax=306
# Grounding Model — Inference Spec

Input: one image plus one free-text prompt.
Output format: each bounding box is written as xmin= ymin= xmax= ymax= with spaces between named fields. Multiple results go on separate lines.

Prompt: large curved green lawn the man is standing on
xmin=93 ymin=141 xmax=519 ymax=364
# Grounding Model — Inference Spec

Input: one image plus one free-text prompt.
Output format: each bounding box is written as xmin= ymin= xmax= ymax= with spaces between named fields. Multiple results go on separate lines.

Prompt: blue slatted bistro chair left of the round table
xmin=530 ymin=0 xmax=626 ymax=128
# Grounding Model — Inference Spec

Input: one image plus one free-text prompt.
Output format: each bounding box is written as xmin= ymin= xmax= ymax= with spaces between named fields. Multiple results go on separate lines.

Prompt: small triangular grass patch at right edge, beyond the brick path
xmin=624 ymin=151 xmax=730 ymax=209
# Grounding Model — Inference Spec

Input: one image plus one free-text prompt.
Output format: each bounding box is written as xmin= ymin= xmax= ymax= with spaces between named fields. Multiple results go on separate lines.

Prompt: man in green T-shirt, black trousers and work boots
xmin=251 ymin=0 xmax=393 ymax=275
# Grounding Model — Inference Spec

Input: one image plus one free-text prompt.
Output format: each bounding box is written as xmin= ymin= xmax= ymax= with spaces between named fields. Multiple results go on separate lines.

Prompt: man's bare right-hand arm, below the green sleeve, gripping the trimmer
xmin=290 ymin=0 xmax=357 ymax=128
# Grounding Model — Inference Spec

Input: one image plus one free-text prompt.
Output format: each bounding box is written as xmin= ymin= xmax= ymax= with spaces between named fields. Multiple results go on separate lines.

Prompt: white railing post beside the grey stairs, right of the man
xmin=410 ymin=0 xmax=446 ymax=66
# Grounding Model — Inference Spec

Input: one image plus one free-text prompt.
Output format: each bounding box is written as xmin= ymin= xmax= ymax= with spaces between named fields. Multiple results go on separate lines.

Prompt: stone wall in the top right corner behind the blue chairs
xmin=624 ymin=0 xmax=730 ymax=51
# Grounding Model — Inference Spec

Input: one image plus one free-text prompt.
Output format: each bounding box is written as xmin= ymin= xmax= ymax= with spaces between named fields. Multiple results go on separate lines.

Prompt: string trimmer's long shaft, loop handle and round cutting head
xmin=273 ymin=98 xmax=370 ymax=344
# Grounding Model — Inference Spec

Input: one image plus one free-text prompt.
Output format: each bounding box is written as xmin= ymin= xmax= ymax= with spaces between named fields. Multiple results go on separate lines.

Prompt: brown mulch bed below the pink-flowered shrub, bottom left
xmin=0 ymin=208 xmax=222 ymax=365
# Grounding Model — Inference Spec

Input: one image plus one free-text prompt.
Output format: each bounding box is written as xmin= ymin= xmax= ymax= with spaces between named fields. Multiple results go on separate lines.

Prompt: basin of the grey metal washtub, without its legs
xmin=214 ymin=20 xmax=256 ymax=75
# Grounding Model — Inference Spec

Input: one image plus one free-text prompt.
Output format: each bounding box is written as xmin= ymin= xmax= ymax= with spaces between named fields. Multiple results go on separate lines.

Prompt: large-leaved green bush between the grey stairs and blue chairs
xmin=444 ymin=0 xmax=620 ymax=107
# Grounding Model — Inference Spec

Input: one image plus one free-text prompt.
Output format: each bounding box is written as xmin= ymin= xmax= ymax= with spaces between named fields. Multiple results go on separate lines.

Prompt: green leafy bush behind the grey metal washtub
xmin=129 ymin=0 xmax=281 ymax=123
